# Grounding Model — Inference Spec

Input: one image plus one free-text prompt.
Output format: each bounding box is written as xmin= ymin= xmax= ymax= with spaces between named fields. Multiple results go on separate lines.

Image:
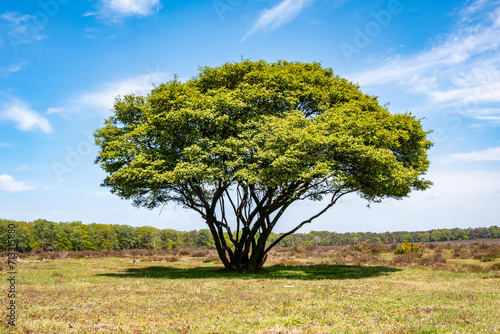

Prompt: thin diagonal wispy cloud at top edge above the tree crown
xmin=243 ymin=0 xmax=314 ymax=40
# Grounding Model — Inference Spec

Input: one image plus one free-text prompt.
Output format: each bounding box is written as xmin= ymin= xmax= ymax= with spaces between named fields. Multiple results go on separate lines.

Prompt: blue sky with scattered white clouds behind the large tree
xmin=0 ymin=0 xmax=500 ymax=233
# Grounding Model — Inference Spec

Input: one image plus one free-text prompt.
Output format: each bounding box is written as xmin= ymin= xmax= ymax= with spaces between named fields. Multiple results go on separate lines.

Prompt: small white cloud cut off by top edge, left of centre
xmin=101 ymin=0 xmax=162 ymax=17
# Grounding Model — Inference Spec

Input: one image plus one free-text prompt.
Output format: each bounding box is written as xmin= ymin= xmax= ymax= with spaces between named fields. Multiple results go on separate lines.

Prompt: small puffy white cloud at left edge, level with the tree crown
xmin=0 ymin=100 xmax=52 ymax=133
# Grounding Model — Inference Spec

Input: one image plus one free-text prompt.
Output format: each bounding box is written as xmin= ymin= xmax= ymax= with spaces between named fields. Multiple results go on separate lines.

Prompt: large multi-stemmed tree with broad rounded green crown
xmin=95 ymin=60 xmax=431 ymax=270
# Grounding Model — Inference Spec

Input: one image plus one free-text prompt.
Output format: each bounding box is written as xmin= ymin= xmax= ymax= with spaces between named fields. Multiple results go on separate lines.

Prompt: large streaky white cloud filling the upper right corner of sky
xmin=351 ymin=0 xmax=500 ymax=121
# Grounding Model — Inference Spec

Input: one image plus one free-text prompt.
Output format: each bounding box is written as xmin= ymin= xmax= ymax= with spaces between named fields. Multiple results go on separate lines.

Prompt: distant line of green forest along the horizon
xmin=0 ymin=219 xmax=500 ymax=252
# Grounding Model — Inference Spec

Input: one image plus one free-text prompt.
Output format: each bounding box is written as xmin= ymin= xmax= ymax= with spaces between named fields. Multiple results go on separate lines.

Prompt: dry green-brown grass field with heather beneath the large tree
xmin=0 ymin=241 xmax=500 ymax=333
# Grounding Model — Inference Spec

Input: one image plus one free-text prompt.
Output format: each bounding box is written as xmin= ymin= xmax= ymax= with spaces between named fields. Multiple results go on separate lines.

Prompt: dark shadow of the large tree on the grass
xmin=98 ymin=264 xmax=401 ymax=280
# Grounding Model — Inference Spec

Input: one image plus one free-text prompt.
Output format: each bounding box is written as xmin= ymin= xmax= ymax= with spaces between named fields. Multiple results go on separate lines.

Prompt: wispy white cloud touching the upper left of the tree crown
xmin=72 ymin=71 xmax=168 ymax=114
